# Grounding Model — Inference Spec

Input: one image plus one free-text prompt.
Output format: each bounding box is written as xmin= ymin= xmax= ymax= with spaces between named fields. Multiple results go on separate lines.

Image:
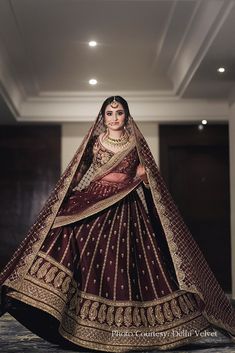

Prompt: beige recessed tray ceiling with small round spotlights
xmin=0 ymin=0 xmax=235 ymax=121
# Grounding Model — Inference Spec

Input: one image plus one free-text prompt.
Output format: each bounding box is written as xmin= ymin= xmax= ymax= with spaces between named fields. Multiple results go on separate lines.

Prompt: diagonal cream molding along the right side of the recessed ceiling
xmin=167 ymin=0 xmax=234 ymax=97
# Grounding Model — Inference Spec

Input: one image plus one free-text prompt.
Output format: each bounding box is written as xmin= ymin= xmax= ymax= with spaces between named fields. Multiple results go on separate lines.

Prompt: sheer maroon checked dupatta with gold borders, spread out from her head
xmin=0 ymin=106 xmax=235 ymax=335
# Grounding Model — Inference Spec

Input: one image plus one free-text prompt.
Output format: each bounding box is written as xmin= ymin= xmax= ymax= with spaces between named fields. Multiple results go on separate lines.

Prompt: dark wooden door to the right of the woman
xmin=160 ymin=124 xmax=231 ymax=292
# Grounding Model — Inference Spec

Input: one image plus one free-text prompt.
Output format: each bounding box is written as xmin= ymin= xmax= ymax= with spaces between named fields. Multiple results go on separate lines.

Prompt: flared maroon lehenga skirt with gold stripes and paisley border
xmin=1 ymin=177 xmax=210 ymax=352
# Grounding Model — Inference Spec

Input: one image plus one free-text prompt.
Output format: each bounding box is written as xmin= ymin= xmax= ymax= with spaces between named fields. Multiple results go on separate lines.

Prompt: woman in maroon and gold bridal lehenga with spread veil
xmin=0 ymin=96 xmax=235 ymax=352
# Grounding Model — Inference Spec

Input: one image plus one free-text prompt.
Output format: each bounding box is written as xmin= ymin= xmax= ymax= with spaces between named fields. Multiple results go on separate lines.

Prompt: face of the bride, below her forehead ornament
xmin=104 ymin=103 xmax=125 ymax=130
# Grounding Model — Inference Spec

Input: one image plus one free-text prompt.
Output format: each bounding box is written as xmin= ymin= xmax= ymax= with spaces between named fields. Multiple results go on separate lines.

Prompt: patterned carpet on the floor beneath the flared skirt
xmin=0 ymin=314 xmax=235 ymax=353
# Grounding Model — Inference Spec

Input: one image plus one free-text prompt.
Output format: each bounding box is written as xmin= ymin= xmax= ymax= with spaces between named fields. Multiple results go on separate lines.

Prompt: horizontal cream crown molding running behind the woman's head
xmin=17 ymin=92 xmax=228 ymax=122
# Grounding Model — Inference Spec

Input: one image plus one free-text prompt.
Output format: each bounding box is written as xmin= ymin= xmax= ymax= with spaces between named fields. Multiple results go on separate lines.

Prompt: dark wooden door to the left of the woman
xmin=0 ymin=125 xmax=61 ymax=268
